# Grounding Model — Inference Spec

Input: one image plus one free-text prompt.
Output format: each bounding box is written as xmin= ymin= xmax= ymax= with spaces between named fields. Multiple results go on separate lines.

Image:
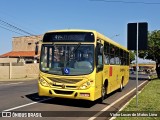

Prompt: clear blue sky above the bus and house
xmin=0 ymin=0 xmax=160 ymax=55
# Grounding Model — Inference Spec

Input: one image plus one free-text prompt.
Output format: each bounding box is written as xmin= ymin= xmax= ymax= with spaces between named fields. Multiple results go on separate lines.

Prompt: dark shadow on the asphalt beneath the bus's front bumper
xmin=25 ymin=93 xmax=97 ymax=108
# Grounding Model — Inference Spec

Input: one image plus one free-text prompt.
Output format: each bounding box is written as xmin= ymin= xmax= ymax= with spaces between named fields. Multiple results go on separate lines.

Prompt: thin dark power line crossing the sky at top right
xmin=90 ymin=0 xmax=160 ymax=5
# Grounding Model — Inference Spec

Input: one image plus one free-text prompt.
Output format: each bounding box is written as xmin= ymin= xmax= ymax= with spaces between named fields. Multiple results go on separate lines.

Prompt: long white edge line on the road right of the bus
xmin=88 ymin=80 xmax=147 ymax=120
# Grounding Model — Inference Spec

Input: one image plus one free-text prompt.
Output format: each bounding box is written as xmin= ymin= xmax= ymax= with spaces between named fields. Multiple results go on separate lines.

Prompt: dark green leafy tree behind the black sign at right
xmin=139 ymin=30 xmax=160 ymax=78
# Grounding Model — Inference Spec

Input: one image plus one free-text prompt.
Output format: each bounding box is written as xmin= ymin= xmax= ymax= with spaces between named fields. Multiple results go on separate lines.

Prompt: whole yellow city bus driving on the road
xmin=38 ymin=29 xmax=129 ymax=101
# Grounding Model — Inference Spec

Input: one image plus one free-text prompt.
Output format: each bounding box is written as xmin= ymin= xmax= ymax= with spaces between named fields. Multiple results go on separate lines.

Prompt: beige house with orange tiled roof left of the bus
xmin=0 ymin=35 xmax=43 ymax=63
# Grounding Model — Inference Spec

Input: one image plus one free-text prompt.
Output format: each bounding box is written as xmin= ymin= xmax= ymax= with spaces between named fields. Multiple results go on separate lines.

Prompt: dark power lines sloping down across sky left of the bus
xmin=0 ymin=19 xmax=33 ymax=36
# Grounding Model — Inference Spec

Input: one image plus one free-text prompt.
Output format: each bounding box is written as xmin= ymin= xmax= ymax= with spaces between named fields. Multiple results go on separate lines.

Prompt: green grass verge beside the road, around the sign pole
xmin=116 ymin=79 xmax=160 ymax=120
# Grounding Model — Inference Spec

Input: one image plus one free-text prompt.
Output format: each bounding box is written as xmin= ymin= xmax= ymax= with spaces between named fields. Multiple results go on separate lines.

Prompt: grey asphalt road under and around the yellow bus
xmin=0 ymin=74 xmax=148 ymax=120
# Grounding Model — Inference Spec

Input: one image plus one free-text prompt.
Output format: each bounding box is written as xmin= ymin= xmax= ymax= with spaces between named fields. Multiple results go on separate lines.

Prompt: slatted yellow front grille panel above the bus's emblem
xmin=48 ymin=77 xmax=82 ymax=84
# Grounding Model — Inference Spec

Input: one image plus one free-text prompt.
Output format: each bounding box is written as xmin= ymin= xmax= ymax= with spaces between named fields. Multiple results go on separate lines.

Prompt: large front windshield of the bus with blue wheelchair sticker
xmin=40 ymin=43 xmax=94 ymax=75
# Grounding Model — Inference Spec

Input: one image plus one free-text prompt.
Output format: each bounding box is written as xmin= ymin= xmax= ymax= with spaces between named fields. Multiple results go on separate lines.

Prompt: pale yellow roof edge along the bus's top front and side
xmin=46 ymin=29 xmax=128 ymax=51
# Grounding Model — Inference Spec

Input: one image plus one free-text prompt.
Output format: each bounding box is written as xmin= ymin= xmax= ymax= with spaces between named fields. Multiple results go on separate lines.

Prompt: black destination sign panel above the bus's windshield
xmin=43 ymin=32 xmax=94 ymax=42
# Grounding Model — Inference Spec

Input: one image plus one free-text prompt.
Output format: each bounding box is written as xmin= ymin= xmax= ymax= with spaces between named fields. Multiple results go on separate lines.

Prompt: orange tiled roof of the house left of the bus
xmin=0 ymin=51 xmax=37 ymax=57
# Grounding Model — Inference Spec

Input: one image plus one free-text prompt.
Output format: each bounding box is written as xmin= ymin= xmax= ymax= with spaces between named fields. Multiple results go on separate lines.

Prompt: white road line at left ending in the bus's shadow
xmin=3 ymin=98 xmax=53 ymax=112
